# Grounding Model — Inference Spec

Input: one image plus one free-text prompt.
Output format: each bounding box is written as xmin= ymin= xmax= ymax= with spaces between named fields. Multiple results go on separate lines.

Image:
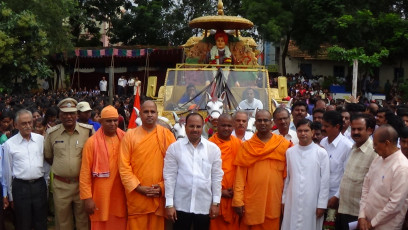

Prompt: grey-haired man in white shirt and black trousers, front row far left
xmin=3 ymin=109 xmax=49 ymax=230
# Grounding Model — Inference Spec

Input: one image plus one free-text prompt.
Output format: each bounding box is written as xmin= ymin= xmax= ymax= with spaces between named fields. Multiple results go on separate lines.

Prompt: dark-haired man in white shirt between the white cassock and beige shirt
xmin=320 ymin=111 xmax=353 ymax=214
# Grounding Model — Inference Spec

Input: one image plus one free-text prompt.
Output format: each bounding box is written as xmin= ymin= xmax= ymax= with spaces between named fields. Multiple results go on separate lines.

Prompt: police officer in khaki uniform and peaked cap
xmin=44 ymin=98 xmax=95 ymax=230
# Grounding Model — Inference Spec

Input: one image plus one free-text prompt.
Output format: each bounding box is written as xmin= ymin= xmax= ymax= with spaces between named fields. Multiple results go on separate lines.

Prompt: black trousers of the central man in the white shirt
xmin=173 ymin=211 xmax=210 ymax=230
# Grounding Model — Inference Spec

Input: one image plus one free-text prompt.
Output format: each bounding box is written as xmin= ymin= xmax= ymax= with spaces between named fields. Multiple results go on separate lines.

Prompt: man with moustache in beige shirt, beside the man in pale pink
xmin=336 ymin=113 xmax=377 ymax=230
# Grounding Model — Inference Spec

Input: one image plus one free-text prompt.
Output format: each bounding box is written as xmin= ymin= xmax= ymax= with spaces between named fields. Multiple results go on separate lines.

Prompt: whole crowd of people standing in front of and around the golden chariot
xmin=0 ymin=73 xmax=408 ymax=230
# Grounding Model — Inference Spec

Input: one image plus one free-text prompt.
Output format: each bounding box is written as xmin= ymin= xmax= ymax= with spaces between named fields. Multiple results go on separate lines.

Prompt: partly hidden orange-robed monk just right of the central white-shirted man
xmin=209 ymin=113 xmax=242 ymax=230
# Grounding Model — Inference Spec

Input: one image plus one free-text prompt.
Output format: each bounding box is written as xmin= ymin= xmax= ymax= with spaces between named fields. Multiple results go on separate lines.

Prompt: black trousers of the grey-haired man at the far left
xmin=12 ymin=177 xmax=47 ymax=230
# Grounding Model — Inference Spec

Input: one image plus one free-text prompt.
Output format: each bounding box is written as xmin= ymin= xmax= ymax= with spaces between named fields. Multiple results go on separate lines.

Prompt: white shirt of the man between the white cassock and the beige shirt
xmin=320 ymin=133 xmax=353 ymax=198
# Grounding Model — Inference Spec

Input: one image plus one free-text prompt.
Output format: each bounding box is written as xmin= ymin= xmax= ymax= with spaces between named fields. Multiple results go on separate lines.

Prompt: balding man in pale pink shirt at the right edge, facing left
xmin=358 ymin=124 xmax=408 ymax=230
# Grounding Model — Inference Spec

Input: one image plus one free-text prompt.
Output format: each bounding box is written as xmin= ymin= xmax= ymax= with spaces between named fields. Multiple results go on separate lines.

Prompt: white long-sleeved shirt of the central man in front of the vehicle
xmin=163 ymin=138 xmax=224 ymax=215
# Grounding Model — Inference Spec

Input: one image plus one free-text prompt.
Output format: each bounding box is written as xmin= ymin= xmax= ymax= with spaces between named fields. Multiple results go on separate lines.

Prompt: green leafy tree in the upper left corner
xmin=0 ymin=3 xmax=52 ymax=92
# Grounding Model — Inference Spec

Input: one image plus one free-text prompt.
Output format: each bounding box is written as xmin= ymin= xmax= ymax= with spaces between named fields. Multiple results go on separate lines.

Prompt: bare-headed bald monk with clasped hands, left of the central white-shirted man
xmin=119 ymin=101 xmax=176 ymax=230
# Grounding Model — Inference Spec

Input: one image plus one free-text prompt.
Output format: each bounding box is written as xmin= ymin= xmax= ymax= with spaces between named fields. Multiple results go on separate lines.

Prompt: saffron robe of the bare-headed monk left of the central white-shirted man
xmin=119 ymin=125 xmax=176 ymax=221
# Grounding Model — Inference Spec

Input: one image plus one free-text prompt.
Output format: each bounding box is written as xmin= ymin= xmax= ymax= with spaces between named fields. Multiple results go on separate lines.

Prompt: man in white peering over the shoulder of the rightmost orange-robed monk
xmin=272 ymin=107 xmax=299 ymax=145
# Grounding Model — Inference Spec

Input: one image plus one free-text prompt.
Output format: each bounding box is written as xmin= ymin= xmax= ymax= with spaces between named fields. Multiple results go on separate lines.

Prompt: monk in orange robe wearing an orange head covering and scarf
xmin=79 ymin=105 xmax=127 ymax=230
